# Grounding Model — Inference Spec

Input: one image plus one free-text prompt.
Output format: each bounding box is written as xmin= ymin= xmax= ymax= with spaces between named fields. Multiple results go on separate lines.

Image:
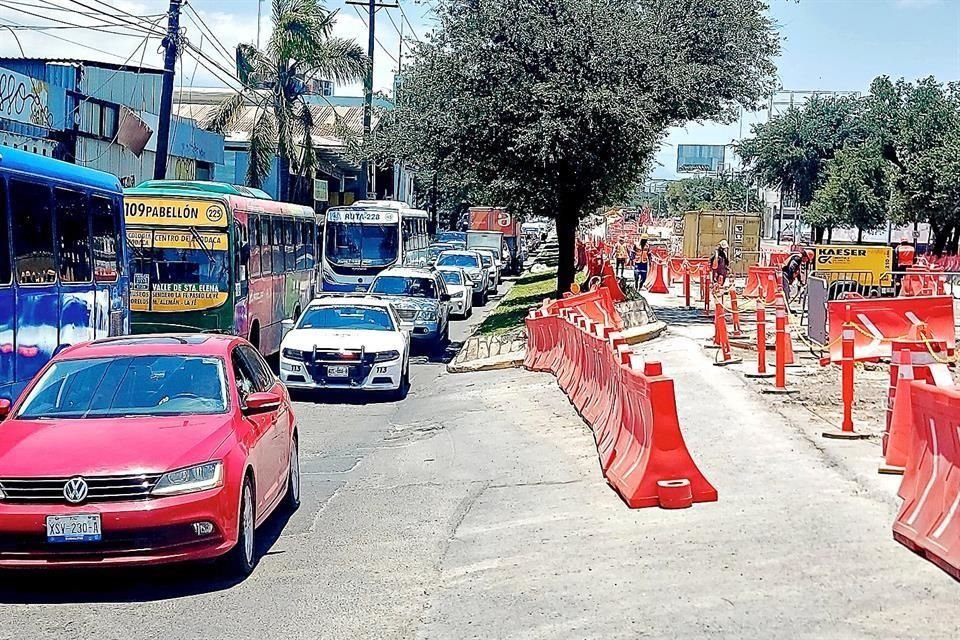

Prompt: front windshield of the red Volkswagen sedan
xmin=17 ymin=355 xmax=227 ymax=420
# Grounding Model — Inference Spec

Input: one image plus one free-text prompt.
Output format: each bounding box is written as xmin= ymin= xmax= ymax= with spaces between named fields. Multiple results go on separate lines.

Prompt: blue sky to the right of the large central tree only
xmin=654 ymin=0 xmax=960 ymax=178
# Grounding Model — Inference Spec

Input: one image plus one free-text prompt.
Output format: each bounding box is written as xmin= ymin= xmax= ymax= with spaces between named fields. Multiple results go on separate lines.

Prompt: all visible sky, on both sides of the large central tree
xmin=0 ymin=0 xmax=960 ymax=177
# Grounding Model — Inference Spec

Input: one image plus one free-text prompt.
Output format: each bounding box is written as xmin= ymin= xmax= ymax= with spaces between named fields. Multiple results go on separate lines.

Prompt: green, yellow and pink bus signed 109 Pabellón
xmin=124 ymin=180 xmax=317 ymax=355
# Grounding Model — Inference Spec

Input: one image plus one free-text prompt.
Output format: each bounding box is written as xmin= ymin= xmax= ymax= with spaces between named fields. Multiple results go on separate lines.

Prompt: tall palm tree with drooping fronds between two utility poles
xmin=207 ymin=0 xmax=370 ymax=199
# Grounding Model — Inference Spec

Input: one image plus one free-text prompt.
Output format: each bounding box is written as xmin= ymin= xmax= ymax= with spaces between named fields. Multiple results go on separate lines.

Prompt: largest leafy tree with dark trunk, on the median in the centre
xmin=376 ymin=0 xmax=779 ymax=290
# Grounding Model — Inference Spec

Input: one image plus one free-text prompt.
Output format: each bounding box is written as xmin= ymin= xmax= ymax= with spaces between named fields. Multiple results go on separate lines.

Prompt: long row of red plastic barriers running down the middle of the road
xmin=524 ymin=292 xmax=717 ymax=508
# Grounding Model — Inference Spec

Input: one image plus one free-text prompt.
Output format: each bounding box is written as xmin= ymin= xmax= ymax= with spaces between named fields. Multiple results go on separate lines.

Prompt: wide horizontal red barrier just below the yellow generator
xmin=827 ymin=296 xmax=956 ymax=362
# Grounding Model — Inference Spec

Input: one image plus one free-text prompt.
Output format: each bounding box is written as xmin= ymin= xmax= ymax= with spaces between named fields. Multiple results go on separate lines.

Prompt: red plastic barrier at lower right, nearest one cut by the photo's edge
xmin=893 ymin=382 xmax=960 ymax=580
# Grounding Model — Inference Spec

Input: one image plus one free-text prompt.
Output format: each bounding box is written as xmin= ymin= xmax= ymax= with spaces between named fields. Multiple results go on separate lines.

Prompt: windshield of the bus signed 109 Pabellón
xmin=127 ymin=228 xmax=230 ymax=311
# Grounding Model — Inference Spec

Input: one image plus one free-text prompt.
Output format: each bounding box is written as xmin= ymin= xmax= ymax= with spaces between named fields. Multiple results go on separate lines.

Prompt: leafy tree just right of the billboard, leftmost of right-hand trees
xmin=737 ymin=96 xmax=870 ymax=239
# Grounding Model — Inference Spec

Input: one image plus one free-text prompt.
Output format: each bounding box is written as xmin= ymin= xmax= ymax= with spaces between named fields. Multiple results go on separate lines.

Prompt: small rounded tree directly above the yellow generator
xmin=807 ymin=145 xmax=890 ymax=242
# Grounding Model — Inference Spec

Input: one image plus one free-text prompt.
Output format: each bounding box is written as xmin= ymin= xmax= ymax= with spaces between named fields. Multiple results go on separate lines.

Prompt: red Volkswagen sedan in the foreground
xmin=0 ymin=335 xmax=300 ymax=575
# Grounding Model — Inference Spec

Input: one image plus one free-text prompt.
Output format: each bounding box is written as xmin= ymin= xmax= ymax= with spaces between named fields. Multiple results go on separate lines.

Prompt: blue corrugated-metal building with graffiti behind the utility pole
xmin=0 ymin=58 xmax=224 ymax=187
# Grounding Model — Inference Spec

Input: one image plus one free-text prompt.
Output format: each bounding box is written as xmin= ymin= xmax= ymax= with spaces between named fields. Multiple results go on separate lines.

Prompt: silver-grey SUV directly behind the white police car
xmin=370 ymin=267 xmax=450 ymax=346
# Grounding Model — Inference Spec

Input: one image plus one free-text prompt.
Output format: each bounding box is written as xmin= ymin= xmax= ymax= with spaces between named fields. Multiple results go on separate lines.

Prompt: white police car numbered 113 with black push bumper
xmin=280 ymin=296 xmax=410 ymax=400
